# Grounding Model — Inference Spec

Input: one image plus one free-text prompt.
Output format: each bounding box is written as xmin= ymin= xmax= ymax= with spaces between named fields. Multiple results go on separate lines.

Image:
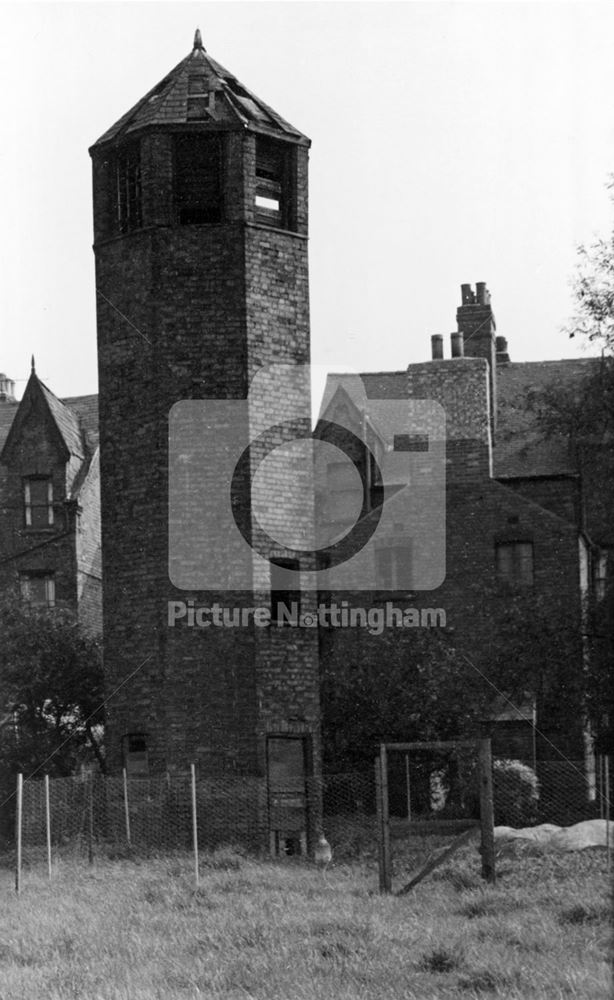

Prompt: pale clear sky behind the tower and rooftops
xmin=0 ymin=0 xmax=614 ymax=396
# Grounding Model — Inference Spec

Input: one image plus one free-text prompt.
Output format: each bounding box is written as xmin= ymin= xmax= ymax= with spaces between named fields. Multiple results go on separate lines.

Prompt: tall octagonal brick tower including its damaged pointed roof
xmin=90 ymin=31 xmax=320 ymax=847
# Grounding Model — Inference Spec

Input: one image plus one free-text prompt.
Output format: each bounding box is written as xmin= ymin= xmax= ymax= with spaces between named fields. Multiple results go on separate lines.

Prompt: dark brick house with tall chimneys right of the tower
xmin=318 ymin=286 xmax=611 ymax=780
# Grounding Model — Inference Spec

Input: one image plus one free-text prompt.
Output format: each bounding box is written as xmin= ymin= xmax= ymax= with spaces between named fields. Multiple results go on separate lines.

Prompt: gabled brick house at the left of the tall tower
xmin=0 ymin=372 xmax=102 ymax=635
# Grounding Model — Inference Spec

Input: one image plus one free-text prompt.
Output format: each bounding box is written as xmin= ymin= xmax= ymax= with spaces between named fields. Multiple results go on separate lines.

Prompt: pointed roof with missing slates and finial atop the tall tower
xmin=91 ymin=29 xmax=309 ymax=149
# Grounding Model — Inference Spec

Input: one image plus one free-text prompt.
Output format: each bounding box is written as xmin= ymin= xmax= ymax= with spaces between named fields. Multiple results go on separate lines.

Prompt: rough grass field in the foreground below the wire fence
xmin=0 ymin=849 xmax=612 ymax=1000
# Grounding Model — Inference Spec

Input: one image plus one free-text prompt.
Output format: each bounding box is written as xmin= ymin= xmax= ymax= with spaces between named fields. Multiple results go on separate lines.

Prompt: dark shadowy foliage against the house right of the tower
xmin=321 ymin=590 xmax=586 ymax=771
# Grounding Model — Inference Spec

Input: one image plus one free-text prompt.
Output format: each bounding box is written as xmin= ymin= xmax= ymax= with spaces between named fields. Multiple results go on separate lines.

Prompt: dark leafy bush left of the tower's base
xmin=0 ymin=600 xmax=104 ymax=784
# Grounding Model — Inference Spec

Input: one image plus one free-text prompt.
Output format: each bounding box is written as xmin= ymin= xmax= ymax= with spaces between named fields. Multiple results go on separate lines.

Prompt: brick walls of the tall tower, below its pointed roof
xmin=94 ymin=121 xmax=319 ymax=820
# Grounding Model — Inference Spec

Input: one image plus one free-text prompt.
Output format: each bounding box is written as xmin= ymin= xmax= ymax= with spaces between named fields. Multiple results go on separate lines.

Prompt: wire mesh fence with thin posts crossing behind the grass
xmin=9 ymin=752 xmax=610 ymax=888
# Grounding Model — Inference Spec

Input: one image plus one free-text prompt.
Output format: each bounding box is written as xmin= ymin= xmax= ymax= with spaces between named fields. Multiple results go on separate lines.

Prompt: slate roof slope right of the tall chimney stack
xmin=494 ymin=358 xmax=600 ymax=478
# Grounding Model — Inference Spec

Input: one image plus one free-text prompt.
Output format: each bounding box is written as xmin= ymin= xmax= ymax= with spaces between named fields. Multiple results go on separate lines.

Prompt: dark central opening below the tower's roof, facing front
xmin=175 ymin=135 xmax=222 ymax=225
